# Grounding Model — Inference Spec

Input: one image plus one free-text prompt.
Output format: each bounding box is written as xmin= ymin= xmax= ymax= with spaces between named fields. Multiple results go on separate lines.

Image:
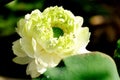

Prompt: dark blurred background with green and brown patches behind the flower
xmin=0 ymin=0 xmax=120 ymax=78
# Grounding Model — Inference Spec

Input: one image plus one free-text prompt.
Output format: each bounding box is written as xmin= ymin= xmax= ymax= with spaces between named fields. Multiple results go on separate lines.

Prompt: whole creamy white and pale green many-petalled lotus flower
xmin=12 ymin=6 xmax=90 ymax=78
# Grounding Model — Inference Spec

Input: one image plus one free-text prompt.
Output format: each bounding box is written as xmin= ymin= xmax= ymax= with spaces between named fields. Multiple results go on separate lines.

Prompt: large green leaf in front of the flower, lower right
xmin=34 ymin=52 xmax=120 ymax=80
